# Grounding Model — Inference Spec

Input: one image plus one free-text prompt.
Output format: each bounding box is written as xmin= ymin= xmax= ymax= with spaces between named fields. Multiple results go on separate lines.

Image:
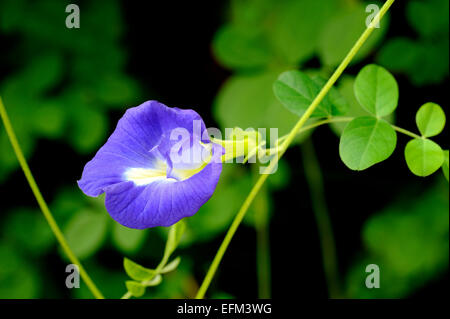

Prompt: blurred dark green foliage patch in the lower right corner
xmin=346 ymin=178 xmax=449 ymax=298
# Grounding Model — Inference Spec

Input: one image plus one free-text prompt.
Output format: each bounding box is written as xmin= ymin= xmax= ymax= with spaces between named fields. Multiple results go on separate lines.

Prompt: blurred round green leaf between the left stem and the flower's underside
xmin=64 ymin=209 xmax=108 ymax=259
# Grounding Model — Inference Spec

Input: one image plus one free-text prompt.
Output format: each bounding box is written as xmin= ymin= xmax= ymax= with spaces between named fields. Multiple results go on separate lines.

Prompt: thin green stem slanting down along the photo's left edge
xmin=0 ymin=97 xmax=104 ymax=299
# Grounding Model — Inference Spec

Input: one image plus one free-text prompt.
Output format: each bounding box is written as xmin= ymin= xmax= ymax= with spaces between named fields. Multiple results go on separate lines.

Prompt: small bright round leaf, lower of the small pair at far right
xmin=405 ymin=139 xmax=444 ymax=176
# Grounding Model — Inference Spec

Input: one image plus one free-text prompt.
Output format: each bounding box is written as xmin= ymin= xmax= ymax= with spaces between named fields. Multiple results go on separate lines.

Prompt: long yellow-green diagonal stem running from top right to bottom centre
xmin=196 ymin=0 xmax=395 ymax=299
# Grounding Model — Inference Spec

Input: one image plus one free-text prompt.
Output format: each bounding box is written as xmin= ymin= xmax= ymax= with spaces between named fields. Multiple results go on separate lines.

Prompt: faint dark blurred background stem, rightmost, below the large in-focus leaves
xmin=301 ymin=139 xmax=342 ymax=298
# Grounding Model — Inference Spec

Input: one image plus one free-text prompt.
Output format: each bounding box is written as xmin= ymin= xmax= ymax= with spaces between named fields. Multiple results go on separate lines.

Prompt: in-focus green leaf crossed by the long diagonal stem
xmin=273 ymin=71 xmax=333 ymax=117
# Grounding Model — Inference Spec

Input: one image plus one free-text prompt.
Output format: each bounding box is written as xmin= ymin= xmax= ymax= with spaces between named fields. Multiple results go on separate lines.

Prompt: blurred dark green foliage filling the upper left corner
xmin=0 ymin=0 xmax=139 ymax=181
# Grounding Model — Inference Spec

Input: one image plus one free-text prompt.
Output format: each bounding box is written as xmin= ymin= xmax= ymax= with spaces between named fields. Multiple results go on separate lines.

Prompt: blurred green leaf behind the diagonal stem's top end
xmin=318 ymin=2 xmax=389 ymax=67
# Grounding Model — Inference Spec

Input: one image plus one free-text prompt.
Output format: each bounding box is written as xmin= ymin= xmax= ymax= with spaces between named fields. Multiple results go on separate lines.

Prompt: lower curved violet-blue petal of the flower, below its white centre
xmin=105 ymin=144 xmax=223 ymax=229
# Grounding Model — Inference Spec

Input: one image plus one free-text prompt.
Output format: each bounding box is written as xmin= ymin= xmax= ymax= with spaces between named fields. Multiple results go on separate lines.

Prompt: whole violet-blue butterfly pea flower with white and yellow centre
xmin=78 ymin=101 xmax=224 ymax=229
